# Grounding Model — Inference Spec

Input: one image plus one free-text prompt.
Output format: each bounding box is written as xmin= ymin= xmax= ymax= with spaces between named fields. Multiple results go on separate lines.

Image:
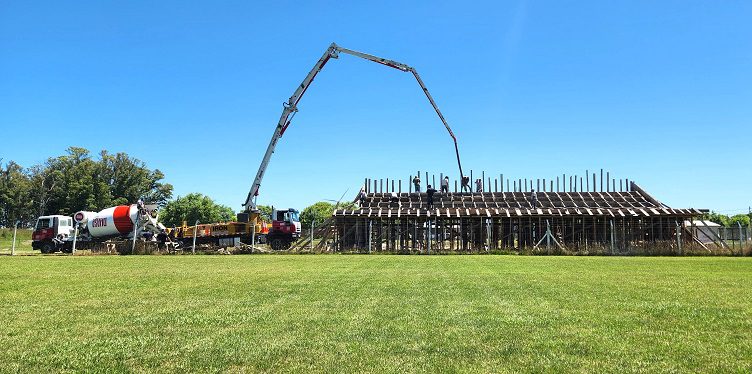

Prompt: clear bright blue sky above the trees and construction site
xmin=0 ymin=0 xmax=752 ymax=213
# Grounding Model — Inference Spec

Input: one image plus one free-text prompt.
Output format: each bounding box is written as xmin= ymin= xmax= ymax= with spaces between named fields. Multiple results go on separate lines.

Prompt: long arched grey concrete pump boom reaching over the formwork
xmin=243 ymin=43 xmax=464 ymax=211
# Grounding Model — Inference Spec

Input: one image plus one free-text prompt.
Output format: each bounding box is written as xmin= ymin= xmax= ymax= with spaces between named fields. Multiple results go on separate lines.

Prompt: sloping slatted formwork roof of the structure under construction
xmin=333 ymin=183 xmax=702 ymax=218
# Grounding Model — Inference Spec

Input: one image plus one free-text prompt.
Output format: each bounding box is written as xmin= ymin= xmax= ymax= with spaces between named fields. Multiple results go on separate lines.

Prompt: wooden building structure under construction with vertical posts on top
xmin=312 ymin=171 xmax=723 ymax=254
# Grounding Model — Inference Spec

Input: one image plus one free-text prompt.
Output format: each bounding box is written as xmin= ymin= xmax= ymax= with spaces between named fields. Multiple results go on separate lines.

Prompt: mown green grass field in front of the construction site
xmin=0 ymin=255 xmax=752 ymax=372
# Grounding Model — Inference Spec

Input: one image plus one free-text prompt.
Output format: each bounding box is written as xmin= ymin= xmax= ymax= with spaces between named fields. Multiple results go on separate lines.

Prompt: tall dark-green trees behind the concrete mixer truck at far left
xmin=0 ymin=147 xmax=173 ymax=227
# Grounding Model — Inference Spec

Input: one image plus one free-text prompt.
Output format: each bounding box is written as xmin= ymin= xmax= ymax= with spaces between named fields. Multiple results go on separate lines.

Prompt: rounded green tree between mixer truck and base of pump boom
xmin=159 ymin=193 xmax=235 ymax=226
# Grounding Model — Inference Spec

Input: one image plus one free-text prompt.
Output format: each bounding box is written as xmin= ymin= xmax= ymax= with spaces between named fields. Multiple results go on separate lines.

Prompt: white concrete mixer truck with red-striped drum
xmin=31 ymin=203 xmax=165 ymax=253
